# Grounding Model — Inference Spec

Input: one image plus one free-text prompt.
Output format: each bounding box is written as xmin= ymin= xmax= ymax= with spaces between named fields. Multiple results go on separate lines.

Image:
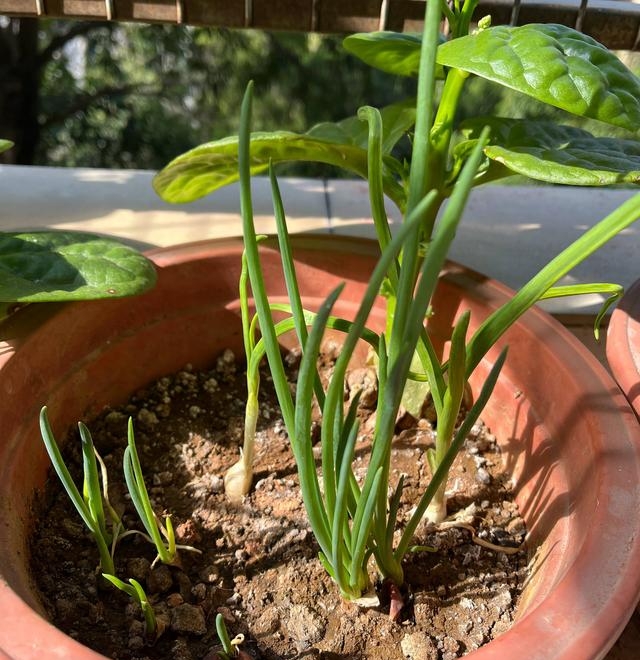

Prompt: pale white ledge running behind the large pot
xmin=0 ymin=166 xmax=640 ymax=314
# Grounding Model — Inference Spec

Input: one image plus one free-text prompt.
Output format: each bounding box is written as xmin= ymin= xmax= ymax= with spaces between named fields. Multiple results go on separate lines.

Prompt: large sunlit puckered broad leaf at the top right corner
xmin=438 ymin=24 xmax=640 ymax=132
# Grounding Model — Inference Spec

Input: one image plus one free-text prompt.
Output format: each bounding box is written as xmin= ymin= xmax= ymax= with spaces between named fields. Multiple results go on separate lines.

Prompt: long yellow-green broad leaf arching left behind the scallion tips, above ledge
xmin=153 ymin=127 xmax=404 ymax=206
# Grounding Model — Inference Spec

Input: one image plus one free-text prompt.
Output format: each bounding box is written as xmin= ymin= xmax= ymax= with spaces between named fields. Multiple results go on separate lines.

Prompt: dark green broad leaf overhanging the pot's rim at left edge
xmin=0 ymin=231 xmax=156 ymax=302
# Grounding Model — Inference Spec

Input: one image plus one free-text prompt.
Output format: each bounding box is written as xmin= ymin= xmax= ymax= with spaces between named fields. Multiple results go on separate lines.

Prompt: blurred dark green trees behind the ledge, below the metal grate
xmin=0 ymin=17 xmax=636 ymax=176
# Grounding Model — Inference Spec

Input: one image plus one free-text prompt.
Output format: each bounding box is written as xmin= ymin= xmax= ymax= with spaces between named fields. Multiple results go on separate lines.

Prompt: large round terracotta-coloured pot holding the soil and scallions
xmin=0 ymin=237 xmax=640 ymax=660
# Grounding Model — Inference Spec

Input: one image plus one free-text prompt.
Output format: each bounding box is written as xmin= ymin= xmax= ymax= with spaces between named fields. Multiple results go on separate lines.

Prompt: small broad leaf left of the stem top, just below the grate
xmin=343 ymin=32 xmax=444 ymax=78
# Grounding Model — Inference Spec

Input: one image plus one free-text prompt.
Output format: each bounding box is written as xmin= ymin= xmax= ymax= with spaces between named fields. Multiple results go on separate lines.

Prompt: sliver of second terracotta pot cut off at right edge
xmin=607 ymin=280 xmax=640 ymax=418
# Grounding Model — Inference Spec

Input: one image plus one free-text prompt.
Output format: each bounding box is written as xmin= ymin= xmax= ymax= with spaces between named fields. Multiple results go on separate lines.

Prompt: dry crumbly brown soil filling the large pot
xmin=31 ymin=352 xmax=527 ymax=660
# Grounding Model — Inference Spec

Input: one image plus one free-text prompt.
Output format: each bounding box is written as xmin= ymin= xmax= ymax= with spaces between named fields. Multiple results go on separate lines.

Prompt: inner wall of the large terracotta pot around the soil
xmin=0 ymin=240 xmax=640 ymax=657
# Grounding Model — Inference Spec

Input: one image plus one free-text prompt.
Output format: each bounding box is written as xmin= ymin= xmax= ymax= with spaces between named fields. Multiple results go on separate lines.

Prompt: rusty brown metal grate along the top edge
xmin=0 ymin=0 xmax=640 ymax=50
